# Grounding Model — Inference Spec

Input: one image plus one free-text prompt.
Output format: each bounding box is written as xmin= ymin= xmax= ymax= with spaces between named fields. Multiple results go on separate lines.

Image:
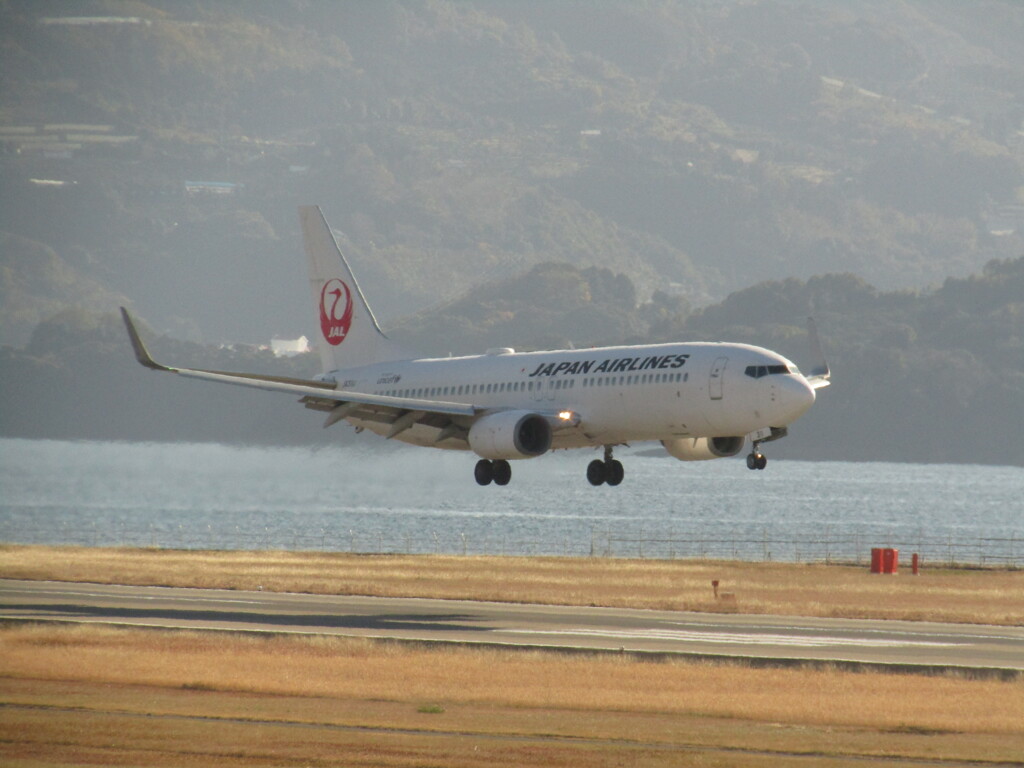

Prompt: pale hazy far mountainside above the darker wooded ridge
xmin=0 ymin=0 xmax=1024 ymax=346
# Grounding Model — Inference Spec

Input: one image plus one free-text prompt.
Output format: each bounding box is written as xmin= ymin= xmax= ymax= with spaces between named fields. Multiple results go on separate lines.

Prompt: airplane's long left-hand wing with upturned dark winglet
xmin=121 ymin=307 xmax=475 ymax=434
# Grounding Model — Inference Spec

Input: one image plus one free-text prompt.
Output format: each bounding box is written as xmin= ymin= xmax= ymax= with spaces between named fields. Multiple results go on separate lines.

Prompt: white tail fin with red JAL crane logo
xmin=299 ymin=206 xmax=404 ymax=373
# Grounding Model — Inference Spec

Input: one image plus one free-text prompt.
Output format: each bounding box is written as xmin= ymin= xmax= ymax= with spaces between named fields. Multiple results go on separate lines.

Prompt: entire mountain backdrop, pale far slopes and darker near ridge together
xmin=0 ymin=0 xmax=1024 ymax=463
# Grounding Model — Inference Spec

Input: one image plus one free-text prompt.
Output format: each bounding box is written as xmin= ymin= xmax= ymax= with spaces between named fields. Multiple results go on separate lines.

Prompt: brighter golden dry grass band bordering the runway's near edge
xmin=0 ymin=626 xmax=1024 ymax=733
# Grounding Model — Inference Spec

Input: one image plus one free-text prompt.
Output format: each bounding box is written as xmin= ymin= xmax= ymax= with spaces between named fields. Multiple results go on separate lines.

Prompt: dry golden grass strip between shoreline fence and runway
xmin=0 ymin=546 xmax=1024 ymax=626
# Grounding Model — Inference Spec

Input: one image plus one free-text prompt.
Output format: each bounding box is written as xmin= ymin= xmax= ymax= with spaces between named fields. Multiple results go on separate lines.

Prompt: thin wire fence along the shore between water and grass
xmin=0 ymin=524 xmax=1024 ymax=568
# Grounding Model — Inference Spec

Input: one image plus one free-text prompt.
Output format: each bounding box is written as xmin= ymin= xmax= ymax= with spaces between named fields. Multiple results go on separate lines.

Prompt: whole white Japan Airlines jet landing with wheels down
xmin=121 ymin=206 xmax=830 ymax=486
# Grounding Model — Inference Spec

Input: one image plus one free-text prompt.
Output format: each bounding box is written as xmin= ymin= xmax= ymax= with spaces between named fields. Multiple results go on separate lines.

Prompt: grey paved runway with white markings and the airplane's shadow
xmin=0 ymin=580 xmax=1024 ymax=677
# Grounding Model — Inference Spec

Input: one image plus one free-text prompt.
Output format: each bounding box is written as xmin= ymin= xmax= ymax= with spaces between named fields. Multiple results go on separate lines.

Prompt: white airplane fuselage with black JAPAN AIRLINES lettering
xmin=330 ymin=342 xmax=814 ymax=450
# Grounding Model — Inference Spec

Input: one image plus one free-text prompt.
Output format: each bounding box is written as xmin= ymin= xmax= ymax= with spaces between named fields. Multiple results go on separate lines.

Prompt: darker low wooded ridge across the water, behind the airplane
xmin=0 ymin=257 xmax=1024 ymax=465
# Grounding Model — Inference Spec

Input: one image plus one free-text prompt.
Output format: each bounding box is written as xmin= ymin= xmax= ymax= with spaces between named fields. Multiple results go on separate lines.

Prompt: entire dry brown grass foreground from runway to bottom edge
xmin=0 ymin=626 xmax=1024 ymax=766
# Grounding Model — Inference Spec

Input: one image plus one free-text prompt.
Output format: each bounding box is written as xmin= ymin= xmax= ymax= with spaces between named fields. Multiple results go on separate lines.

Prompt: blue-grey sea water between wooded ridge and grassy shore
xmin=0 ymin=439 xmax=1024 ymax=565
